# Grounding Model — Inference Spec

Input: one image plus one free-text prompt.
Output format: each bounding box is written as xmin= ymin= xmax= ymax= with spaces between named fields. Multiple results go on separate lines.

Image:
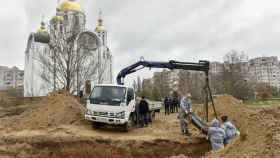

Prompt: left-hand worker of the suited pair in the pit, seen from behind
xmin=206 ymin=119 xmax=226 ymax=151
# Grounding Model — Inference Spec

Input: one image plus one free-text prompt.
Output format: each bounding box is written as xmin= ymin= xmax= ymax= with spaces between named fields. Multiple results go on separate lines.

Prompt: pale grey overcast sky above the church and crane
xmin=0 ymin=0 xmax=280 ymax=83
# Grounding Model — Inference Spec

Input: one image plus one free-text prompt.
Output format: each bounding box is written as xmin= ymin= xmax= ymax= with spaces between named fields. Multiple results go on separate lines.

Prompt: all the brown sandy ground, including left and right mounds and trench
xmin=0 ymin=93 xmax=280 ymax=158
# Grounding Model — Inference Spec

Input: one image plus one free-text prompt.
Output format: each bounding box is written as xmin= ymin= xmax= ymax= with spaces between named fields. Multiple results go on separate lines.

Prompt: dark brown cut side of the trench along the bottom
xmin=0 ymin=136 xmax=210 ymax=158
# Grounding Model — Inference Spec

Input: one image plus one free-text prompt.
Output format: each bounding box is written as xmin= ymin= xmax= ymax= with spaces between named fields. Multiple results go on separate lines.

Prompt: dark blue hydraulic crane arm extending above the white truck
xmin=117 ymin=60 xmax=209 ymax=85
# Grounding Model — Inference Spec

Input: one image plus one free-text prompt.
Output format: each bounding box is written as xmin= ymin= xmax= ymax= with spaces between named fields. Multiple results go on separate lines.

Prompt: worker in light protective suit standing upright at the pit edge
xmin=179 ymin=96 xmax=192 ymax=136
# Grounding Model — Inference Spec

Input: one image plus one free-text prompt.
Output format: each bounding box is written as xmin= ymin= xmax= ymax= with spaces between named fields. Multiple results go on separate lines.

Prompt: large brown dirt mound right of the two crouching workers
xmin=208 ymin=96 xmax=280 ymax=158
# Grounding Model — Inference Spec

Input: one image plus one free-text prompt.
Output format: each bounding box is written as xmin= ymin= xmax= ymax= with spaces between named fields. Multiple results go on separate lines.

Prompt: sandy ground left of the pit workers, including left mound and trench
xmin=0 ymin=93 xmax=210 ymax=158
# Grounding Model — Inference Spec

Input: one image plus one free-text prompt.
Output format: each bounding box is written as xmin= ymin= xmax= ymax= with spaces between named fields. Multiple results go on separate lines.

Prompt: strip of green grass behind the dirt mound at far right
xmin=244 ymin=98 xmax=280 ymax=107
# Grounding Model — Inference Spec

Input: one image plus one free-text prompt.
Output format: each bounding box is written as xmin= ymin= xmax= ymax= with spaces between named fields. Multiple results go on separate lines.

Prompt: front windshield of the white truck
xmin=89 ymin=86 xmax=126 ymax=106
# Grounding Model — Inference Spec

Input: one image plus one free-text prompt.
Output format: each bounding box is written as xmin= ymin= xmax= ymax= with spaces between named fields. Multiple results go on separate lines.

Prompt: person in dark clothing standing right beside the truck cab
xmin=139 ymin=96 xmax=150 ymax=127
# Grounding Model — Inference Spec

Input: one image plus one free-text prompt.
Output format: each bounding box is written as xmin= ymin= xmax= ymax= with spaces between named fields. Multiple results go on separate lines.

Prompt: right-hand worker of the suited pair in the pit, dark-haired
xmin=221 ymin=115 xmax=240 ymax=145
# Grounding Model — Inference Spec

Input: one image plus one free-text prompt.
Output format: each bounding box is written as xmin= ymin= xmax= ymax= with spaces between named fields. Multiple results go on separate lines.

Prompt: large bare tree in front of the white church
xmin=36 ymin=12 xmax=103 ymax=93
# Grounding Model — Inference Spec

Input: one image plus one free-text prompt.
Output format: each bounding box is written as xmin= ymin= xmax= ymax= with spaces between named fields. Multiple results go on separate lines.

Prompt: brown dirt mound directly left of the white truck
xmin=8 ymin=92 xmax=85 ymax=130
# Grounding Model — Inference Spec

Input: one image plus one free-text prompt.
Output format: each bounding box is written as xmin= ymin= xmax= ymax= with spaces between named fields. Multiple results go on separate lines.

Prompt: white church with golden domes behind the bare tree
xmin=24 ymin=0 xmax=113 ymax=97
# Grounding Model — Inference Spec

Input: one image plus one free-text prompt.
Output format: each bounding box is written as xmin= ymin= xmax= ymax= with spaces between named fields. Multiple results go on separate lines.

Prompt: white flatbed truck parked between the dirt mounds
xmin=85 ymin=84 xmax=162 ymax=131
